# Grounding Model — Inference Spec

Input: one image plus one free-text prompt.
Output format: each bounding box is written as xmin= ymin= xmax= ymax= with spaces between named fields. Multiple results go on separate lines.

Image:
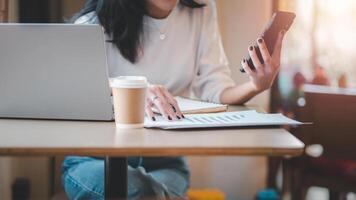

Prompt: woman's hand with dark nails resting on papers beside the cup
xmin=146 ymin=85 xmax=184 ymax=121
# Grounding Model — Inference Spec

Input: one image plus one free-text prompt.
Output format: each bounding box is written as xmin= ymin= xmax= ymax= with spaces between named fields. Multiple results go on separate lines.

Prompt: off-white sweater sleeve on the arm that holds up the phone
xmin=192 ymin=0 xmax=235 ymax=103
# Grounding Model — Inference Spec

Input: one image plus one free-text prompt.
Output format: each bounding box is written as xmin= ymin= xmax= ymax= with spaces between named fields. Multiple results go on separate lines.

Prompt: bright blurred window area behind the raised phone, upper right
xmin=272 ymin=0 xmax=356 ymax=115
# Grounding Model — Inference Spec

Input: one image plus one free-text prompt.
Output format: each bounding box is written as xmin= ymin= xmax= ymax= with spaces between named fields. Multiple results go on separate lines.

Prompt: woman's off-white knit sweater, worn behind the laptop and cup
xmin=76 ymin=0 xmax=235 ymax=103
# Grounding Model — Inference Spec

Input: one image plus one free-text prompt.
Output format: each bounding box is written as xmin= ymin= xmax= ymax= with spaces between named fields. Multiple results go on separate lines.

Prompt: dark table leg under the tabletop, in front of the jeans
xmin=105 ymin=157 xmax=127 ymax=200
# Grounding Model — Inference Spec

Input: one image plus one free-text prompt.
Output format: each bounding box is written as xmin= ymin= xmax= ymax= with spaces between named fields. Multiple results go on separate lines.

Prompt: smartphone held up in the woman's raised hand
xmin=240 ymin=11 xmax=295 ymax=73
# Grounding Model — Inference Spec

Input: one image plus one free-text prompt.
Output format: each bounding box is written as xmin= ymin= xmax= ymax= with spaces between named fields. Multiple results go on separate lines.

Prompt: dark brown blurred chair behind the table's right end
xmin=283 ymin=85 xmax=356 ymax=200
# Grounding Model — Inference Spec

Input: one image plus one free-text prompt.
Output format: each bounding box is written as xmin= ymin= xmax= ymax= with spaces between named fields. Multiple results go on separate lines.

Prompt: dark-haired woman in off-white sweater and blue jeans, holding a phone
xmin=63 ymin=0 xmax=284 ymax=199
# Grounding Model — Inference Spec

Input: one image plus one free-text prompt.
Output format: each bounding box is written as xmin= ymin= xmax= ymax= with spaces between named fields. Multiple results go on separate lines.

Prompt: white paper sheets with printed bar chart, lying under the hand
xmin=145 ymin=110 xmax=302 ymax=129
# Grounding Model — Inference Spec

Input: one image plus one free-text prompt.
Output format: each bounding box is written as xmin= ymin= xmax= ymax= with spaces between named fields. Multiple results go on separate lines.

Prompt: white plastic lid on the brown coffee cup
xmin=110 ymin=76 xmax=148 ymax=88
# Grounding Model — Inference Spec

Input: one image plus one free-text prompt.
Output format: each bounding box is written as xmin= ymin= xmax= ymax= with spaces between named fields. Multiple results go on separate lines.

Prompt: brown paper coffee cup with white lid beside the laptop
xmin=110 ymin=76 xmax=148 ymax=129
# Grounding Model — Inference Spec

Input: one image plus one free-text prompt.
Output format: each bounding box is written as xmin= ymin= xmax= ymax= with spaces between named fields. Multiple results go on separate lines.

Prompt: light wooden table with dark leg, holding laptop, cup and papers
xmin=0 ymin=107 xmax=304 ymax=198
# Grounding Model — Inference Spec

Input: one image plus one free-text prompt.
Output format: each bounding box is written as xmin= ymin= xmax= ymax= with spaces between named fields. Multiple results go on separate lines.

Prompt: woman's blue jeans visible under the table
xmin=62 ymin=156 xmax=189 ymax=200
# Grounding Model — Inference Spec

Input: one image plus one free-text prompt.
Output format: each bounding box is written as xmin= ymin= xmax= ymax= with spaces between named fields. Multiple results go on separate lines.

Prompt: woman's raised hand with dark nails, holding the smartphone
xmin=242 ymin=30 xmax=285 ymax=93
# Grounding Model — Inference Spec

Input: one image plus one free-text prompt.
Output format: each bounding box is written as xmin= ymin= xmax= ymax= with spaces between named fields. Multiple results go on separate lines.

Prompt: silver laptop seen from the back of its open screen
xmin=0 ymin=24 xmax=113 ymax=121
